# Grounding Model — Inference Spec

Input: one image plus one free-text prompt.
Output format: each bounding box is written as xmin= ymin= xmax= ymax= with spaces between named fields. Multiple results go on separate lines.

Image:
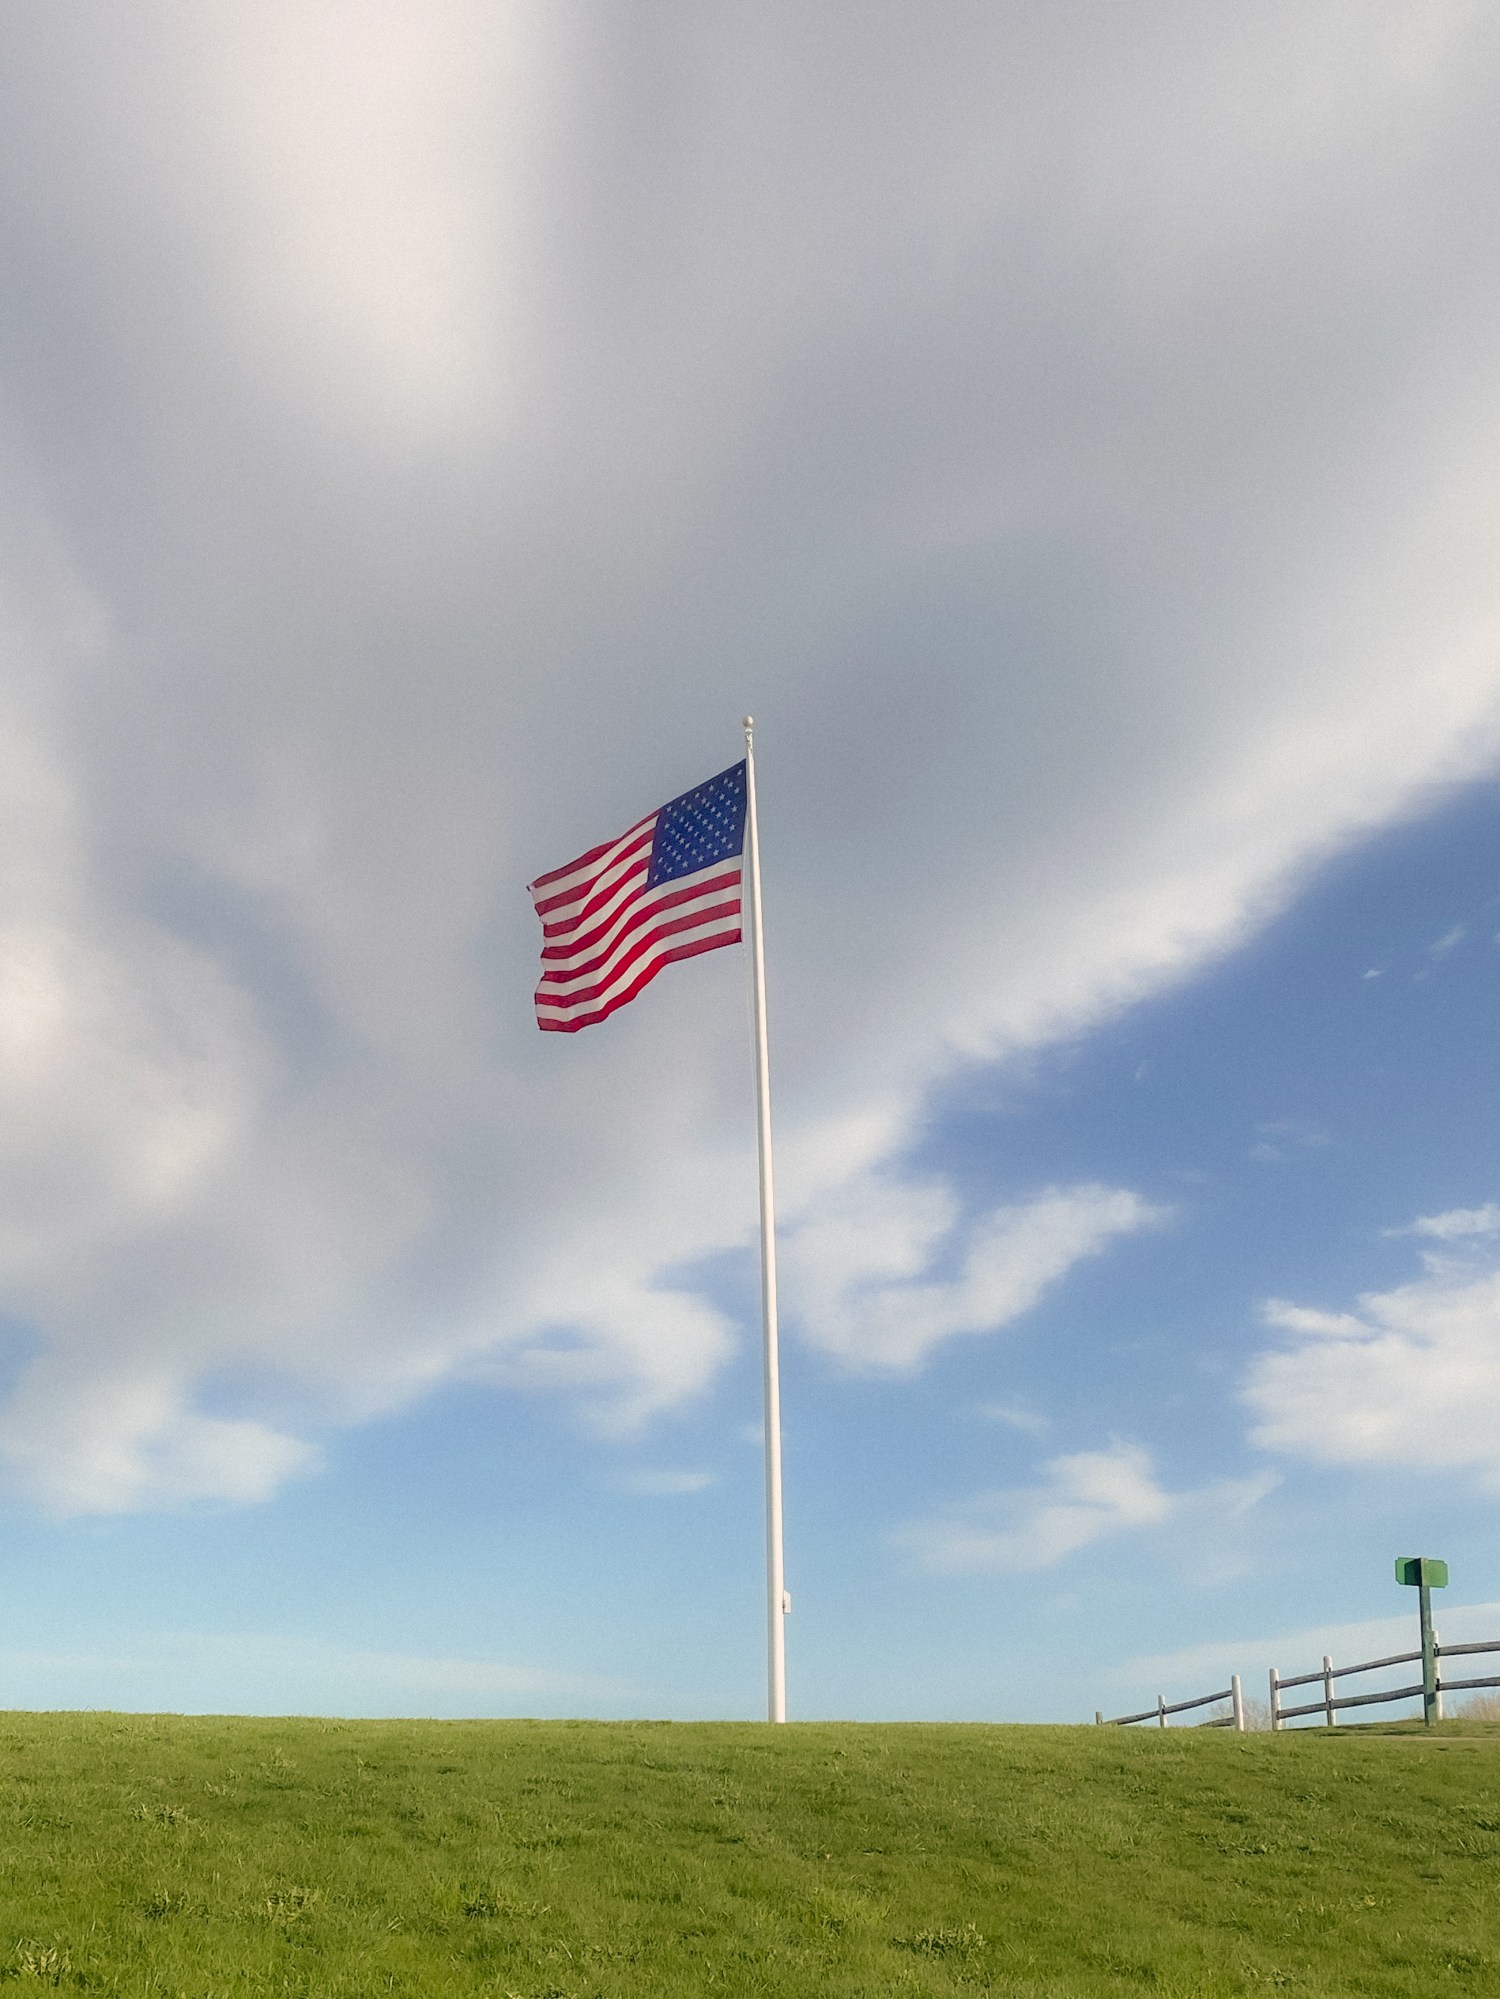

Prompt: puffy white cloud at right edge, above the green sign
xmin=1244 ymin=1209 xmax=1500 ymax=1483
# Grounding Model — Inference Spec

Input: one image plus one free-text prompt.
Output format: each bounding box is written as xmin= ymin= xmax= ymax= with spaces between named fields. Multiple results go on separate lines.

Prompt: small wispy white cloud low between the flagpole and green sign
xmin=896 ymin=1443 xmax=1276 ymax=1575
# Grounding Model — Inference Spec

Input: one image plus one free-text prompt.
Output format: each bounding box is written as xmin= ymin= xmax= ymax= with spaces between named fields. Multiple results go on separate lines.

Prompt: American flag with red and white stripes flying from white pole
xmin=532 ymin=762 xmax=744 ymax=1033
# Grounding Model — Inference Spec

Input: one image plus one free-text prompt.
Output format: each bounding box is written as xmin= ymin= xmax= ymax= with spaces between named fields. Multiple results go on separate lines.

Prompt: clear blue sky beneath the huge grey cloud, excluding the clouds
xmin=4 ymin=784 xmax=1500 ymax=1719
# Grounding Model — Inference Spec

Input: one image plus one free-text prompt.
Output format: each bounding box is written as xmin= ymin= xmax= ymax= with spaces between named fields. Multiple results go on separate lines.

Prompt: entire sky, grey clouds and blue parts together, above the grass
xmin=0 ymin=0 xmax=1500 ymax=1719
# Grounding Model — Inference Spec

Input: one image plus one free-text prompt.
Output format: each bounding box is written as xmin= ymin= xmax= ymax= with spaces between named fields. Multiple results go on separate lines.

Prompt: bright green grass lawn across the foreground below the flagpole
xmin=0 ymin=1715 xmax=1500 ymax=1999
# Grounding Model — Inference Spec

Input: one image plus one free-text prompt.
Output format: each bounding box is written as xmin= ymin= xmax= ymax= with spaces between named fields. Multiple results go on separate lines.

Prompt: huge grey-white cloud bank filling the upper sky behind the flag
xmin=0 ymin=0 xmax=1500 ymax=1507
